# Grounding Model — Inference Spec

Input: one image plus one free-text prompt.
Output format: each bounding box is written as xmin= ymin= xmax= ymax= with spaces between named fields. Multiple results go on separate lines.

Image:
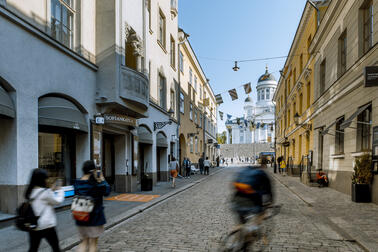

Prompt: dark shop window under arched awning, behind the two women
xmin=38 ymin=130 xmax=76 ymax=185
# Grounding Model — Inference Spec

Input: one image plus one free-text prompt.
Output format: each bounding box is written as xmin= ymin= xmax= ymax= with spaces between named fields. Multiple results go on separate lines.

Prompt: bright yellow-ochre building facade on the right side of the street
xmin=273 ymin=2 xmax=322 ymax=175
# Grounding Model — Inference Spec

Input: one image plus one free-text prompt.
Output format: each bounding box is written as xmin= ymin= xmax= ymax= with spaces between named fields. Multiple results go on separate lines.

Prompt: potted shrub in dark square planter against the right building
xmin=352 ymin=153 xmax=373 ymax=202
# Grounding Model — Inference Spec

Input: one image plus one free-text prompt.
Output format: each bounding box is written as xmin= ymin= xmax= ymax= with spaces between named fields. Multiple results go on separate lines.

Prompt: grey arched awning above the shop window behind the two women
xmin=38 ymin=96 xmax=88 ymax=132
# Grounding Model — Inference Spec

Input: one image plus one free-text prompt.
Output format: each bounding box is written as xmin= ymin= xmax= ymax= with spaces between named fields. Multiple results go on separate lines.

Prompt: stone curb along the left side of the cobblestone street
xmin=58 ymin=167 xmax=225 ymax=251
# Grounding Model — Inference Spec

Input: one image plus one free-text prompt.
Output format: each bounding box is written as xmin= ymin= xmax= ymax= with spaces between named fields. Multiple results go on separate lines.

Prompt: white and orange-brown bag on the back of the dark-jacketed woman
xmin=71 ymin=195 xmax=94 ymax=222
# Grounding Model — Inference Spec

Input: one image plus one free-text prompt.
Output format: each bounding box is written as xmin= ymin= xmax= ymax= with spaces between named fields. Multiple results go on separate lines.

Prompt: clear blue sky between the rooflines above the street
xmin=179 ymin=0 xmax=306 ymax=132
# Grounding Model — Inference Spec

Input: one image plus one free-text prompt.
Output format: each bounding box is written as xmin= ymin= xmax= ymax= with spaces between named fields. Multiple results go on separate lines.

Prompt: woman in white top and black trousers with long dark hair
xmin=25 ymin=168 xmax=64 ymax=252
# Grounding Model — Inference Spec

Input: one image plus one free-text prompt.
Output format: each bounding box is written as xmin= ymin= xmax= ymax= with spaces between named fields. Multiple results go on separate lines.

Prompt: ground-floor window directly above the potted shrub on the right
xmin=357 ymin=106 xmax=371 ymax=151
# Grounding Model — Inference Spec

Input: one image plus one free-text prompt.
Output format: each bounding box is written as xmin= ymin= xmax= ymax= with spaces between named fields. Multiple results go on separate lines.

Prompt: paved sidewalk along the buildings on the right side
xmin=269 ymin=169 xmax=378 ymax=251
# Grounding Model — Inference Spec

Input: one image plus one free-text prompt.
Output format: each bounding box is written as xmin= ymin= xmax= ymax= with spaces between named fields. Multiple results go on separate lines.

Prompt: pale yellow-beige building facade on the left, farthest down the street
xmin=179 ymin=40 xmax=216 ymax=172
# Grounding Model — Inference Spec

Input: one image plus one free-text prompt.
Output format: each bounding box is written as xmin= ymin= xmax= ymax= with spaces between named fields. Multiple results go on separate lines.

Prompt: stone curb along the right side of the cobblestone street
xmin=272 ymin=173 xmax=374 ymax=252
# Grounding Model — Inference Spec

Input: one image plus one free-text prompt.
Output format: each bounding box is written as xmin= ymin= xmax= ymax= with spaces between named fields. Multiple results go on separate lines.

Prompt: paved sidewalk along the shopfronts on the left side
xmin=0 ymin=167 xmax=224 ymax=252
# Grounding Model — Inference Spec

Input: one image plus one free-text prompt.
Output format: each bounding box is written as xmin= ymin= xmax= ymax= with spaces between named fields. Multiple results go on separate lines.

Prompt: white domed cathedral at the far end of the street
xmin=225 ymin=68 xmax=277 ymax=144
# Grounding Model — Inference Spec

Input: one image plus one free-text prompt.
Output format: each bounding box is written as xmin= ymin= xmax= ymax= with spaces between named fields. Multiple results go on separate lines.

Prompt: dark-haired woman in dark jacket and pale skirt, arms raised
xmin=74 ymin=160 xmax=110 ymax=252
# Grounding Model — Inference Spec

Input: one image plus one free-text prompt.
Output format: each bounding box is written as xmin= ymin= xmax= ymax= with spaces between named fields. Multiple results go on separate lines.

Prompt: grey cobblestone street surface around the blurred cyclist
xmin=85 ymin=168 xmax=363 ymax=252
